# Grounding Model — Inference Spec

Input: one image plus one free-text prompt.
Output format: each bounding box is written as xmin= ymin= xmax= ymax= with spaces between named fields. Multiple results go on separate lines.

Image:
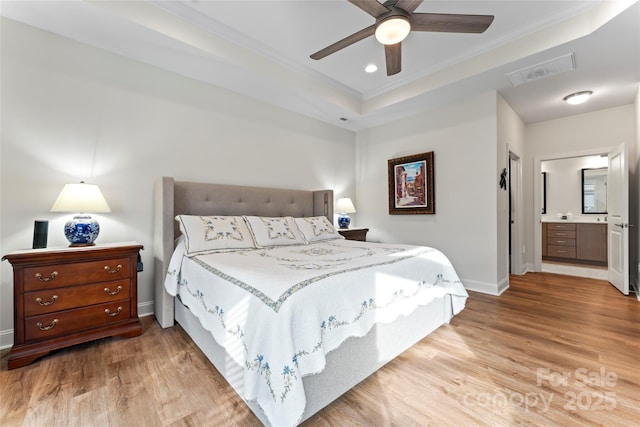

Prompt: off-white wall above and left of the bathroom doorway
xmin=523 ymin=105 xmax=638 ymax=270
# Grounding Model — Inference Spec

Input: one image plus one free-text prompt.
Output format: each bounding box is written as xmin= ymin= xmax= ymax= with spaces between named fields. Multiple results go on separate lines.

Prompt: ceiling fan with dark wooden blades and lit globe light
xmin=311 ymin=0 xmax=493 ymax=76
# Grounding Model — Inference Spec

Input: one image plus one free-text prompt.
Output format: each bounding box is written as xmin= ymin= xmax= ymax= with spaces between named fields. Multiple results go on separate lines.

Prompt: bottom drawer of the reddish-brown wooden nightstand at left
xmin=24 ymin=300 xmax=131 ymax=340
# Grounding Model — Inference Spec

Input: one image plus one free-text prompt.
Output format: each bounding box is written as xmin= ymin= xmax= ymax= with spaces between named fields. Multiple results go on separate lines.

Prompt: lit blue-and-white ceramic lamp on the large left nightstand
xmin=51 ymin=181 xmax=111 ymax=246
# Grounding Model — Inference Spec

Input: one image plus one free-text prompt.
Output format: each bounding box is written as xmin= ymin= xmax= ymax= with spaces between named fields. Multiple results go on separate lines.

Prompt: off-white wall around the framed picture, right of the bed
xmin=356 ymin=92 xmax=498 ymax=293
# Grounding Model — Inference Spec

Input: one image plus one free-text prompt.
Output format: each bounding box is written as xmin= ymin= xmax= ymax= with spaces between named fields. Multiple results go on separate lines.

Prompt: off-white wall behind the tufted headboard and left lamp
xmin=0 ymin=18 xmax=357 ymax=346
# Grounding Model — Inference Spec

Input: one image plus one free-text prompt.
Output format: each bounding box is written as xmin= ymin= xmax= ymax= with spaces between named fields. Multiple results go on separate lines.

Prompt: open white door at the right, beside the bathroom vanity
xmin=607 ymin=143 xmax=629 ymax=295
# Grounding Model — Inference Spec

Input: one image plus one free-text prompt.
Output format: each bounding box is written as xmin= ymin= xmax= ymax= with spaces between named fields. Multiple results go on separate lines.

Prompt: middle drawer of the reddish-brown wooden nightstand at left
xmin=24 ymin=279 xmax=130 ymax=316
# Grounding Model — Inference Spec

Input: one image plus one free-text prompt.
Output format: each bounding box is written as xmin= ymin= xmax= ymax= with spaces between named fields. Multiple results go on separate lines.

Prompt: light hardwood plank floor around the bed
xmin=0 ymin=273 xmax=640 ymax=427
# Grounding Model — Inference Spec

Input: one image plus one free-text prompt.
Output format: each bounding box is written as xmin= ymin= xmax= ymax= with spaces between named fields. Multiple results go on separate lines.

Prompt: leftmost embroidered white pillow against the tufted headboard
xmin=176 ymin=215 xmax=256 ymax=256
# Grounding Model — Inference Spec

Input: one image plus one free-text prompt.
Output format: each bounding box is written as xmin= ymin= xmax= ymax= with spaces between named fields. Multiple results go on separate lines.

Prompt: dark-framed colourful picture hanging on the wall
xmin=388 ymin=151 xmax=436 ymax=215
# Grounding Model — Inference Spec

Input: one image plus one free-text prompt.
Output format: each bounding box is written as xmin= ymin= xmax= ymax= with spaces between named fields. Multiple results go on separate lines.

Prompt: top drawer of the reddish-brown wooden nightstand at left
xmin=24 ymin=258 xmax=130 ymax=291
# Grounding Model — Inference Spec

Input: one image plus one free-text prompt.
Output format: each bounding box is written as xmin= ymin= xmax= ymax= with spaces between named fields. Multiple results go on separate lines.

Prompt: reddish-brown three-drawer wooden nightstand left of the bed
xmin=2 ymin=242 xmax=142 ymax=369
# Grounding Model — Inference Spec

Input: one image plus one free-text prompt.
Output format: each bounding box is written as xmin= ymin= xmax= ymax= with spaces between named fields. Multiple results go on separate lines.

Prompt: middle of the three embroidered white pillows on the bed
xmin=244 ymin=216 xmax=307 ymax=247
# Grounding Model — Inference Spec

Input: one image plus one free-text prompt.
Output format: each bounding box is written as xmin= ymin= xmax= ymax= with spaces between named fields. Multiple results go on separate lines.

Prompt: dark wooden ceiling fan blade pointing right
xmin=411 ymin=13 xmax=493 ymax=33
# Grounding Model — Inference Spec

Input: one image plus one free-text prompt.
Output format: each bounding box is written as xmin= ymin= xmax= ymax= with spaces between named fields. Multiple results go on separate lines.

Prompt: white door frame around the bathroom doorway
xmin=533 ymin=146 xmax=615 ymax=272
